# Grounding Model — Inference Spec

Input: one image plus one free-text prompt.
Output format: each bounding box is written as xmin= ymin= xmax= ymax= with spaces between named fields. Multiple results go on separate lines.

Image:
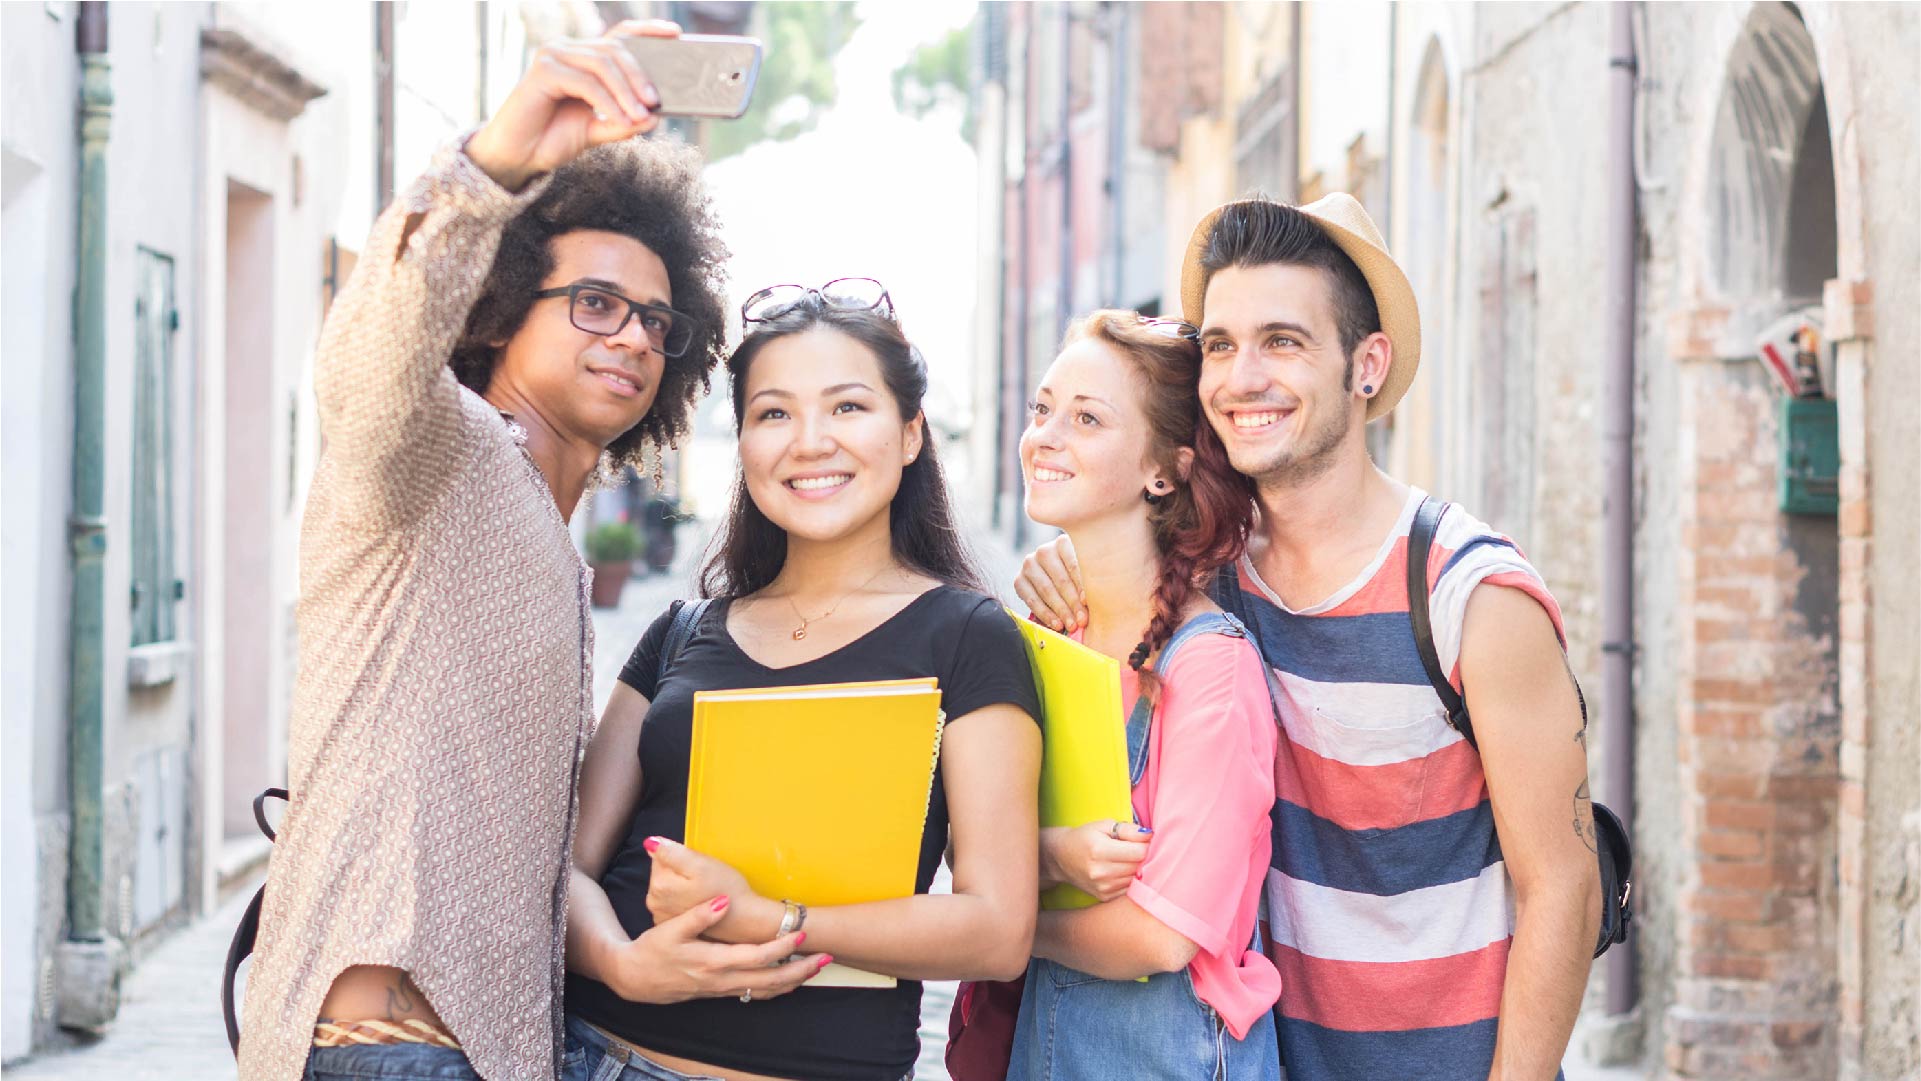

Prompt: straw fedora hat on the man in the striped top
xmin=1181 ymin=192 xmax=1422 ymax=420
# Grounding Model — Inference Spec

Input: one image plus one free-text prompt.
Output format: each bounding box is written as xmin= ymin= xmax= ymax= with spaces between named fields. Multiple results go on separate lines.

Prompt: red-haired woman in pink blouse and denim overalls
xmin=1009 ymin=311 xmax=1281 ymax=1081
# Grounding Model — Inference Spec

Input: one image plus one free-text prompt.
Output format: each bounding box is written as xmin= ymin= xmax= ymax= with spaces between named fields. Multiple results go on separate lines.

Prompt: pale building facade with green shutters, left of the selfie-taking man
xmin=0 ymin=0 xmax=649 ymax=1064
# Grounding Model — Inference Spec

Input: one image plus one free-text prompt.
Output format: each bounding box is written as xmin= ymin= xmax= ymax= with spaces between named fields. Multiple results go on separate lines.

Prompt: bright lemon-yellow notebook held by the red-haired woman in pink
xmin=1009 ymin=613 xmax=1133 ymax=908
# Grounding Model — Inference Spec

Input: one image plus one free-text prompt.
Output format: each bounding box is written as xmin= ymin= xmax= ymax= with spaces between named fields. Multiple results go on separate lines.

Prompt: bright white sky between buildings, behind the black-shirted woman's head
xmin=688 ymin=0 xmax=976 ymax=513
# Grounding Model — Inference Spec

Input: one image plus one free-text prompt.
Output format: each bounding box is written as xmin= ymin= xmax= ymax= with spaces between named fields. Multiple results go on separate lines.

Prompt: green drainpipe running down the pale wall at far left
xmin=56 ymin=0 xmax=125 ymax=1031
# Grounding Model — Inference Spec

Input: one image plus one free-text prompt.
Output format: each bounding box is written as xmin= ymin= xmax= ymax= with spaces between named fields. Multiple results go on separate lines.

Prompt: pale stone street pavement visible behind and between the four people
xmin=6 ymin=526 xmax=1641 ymax=1081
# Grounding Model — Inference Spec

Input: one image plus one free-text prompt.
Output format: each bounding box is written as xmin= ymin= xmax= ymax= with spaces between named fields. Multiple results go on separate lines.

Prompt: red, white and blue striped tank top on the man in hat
xmin=1222 ymin=490 xmax=1562 ymax=1081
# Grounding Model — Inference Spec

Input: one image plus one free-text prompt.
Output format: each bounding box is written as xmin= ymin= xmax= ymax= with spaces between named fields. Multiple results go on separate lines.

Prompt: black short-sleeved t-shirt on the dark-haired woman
xmin=567 ymin=586 xmax=1041 ymax=1081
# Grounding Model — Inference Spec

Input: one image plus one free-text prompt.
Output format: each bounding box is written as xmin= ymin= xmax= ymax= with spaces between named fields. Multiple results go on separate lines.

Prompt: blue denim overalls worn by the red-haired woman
xmin=1007 ymin=613 xmax=1281 ymax=1081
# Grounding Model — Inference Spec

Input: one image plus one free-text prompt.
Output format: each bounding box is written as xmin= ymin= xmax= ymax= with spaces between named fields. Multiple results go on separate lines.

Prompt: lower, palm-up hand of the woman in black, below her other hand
xmin=599 ymin=897 xmax=834 ymax=1004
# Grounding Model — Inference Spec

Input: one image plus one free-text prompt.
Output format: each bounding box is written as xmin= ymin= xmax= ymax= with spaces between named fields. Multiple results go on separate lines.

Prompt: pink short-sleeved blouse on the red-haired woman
xmin=1122 ymin=634 xmax=1281 ymax=1039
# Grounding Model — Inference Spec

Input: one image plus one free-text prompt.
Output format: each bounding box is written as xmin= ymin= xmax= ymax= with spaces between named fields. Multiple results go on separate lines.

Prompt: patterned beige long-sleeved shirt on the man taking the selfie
xmin=240 ymin=148 xmax=594 ymax=1081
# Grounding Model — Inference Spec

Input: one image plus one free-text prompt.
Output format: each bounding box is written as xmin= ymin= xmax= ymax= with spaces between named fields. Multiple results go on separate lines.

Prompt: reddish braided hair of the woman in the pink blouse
xmin=1062 ymin=309 xmax=1254 ymax=695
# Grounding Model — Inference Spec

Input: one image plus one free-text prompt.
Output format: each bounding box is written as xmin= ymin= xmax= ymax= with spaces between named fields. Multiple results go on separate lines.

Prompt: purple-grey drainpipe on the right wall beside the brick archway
xmin=1600 ymin=4 xmax=1639 ymax=1016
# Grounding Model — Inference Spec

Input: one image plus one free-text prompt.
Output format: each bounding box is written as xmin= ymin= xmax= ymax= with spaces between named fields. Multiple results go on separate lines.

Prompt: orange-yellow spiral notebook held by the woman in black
xmin=688 ymin=678 xmax=945 ymax=987
